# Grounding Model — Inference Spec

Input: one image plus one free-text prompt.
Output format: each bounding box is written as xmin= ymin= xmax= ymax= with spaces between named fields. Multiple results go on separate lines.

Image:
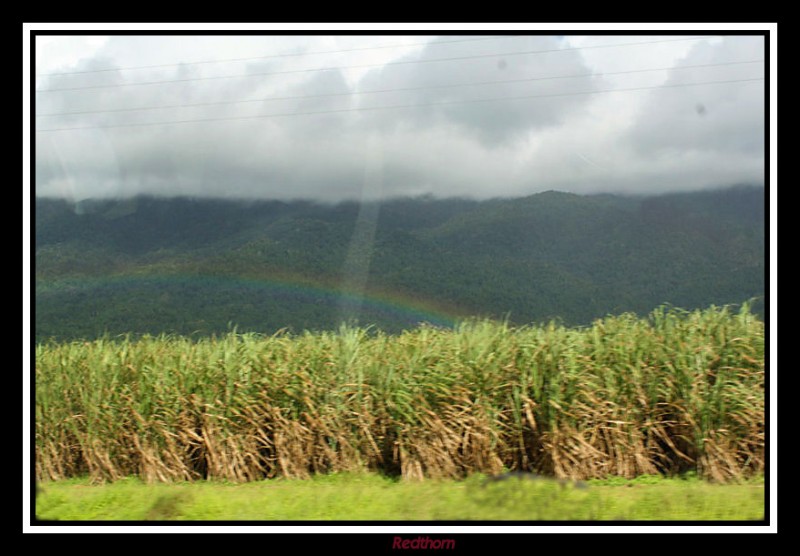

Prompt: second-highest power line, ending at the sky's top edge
xmin=36 ymin=37 xmax=708 ymax=93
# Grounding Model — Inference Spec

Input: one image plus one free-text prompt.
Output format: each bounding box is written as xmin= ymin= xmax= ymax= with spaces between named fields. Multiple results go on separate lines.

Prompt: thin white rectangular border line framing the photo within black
xmin=22 ymin=22 xmax=778 ymax=535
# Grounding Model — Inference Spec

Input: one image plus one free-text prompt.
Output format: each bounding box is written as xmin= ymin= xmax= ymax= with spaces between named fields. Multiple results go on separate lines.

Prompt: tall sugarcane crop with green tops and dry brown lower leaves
xmin=35 ymin=304 xmax=764 ymax=482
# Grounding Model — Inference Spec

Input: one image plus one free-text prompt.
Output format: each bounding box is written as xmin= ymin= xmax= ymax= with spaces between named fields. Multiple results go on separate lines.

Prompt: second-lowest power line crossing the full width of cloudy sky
xmin=36 ymin=60 xmax=764 ymax=118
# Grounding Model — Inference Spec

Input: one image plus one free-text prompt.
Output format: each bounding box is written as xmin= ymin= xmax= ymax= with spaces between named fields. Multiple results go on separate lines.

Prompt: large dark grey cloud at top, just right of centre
xmin=359 ymin=36 xmax=600 ymax=147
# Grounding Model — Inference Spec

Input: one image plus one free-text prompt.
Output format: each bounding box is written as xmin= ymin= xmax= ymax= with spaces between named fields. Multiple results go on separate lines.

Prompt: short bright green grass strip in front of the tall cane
xmin=36 ymin=474 xmax=764 ymax=522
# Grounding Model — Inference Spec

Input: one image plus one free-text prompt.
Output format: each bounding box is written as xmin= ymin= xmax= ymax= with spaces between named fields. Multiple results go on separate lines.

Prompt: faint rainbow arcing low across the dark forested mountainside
xmin=36 ymin=272 xmax=461 ymax=328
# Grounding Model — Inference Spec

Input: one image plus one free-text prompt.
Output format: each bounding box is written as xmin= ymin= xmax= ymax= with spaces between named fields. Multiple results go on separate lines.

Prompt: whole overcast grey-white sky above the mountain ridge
xmin=32 ymin=29 xmax=765 ymax=201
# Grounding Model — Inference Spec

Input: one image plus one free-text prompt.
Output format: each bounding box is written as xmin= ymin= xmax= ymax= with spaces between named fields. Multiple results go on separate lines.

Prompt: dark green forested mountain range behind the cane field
xmin=34 ymin=186 xmax=765 ymax=340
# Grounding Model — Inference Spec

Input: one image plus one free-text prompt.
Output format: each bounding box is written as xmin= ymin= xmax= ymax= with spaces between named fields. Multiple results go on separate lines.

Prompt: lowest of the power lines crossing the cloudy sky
xmin=36 ymin=77 xmax=764 ymax=133
